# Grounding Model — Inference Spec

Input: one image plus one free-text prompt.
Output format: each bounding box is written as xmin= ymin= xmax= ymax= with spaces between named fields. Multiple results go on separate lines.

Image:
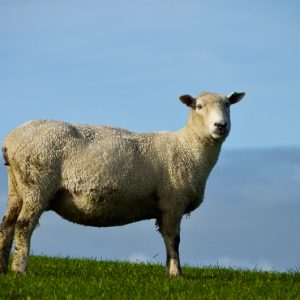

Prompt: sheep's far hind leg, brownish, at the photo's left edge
xmin=0 ymin=172 xmax=22 ymax=273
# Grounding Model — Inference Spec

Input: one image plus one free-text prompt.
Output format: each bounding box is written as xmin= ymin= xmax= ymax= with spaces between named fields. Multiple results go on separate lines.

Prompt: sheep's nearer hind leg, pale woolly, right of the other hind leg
xmin=12 ymin=194 xmax=45 ymax=273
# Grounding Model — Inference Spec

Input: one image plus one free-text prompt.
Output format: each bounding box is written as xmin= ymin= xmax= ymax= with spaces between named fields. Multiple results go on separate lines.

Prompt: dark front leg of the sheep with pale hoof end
xmin=158 ymin=215 xmax=181 ymax=276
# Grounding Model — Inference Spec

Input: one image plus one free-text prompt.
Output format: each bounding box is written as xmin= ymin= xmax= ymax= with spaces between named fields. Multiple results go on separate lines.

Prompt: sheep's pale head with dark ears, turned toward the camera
xmin=179 ymin=92 xmax=245 ymax=140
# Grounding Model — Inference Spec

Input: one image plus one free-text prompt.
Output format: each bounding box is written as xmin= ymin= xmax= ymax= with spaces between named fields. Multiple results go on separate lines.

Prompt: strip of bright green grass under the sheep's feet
xmin=0 ymin=256 xmax=300 ymax=299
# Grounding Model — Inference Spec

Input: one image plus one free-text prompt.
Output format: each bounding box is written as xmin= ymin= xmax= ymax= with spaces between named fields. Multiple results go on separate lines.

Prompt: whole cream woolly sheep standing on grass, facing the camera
xmin=0 ymin=92 xmax=245 ymax=276
